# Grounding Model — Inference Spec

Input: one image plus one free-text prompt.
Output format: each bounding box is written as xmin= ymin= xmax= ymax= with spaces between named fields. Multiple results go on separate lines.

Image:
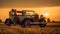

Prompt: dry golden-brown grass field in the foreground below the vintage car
xmin=0 ymin=24 xmax=60 ymax=34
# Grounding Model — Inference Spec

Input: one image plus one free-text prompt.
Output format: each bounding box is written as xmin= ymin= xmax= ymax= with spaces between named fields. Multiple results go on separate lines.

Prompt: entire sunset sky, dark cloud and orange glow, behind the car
xmin=0 ymin=0 xmax=60 ymax=21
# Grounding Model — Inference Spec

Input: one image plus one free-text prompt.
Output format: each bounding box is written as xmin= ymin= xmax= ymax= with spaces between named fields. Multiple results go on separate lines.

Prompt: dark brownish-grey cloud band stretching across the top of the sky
xmin=0 ymin=0 xmax=60 ymax=8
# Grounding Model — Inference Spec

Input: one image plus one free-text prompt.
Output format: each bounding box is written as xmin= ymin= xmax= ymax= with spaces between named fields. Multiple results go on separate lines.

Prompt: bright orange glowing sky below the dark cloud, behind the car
xmin=0 ymin=6 xmax=60 ymax=21
